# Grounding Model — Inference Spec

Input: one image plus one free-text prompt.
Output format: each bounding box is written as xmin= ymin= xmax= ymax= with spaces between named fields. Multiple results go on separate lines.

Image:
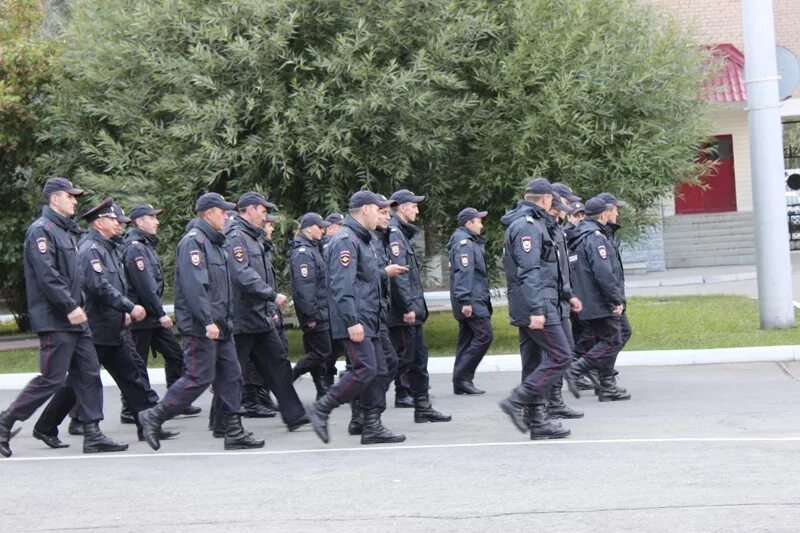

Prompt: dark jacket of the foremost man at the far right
xmin=568 ymin=219 xmax=625 ymax=320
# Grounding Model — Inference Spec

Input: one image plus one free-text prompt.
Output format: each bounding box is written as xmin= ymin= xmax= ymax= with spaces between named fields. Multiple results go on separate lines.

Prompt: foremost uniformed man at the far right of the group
xmin=568 ymin=196 xmax=631 ymax=402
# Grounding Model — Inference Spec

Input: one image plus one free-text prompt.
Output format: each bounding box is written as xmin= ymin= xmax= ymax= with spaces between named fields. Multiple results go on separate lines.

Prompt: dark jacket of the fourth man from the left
xmin=175 ymin=219 xmax=233 ymax=339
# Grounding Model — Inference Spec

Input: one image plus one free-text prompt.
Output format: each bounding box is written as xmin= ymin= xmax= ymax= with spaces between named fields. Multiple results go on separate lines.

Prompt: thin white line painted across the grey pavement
xmin=0 ymin=436 xmax=800 ymax=464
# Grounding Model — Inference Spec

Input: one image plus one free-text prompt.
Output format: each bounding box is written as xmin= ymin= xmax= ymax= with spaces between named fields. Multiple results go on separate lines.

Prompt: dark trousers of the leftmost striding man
xmin=7 ymin=329 xmax=103 ymax=422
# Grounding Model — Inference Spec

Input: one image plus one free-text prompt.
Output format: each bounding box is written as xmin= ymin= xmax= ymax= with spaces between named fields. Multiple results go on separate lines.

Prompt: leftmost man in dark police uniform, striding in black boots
xmin=0 ymin=181 xmax=128 ymax=457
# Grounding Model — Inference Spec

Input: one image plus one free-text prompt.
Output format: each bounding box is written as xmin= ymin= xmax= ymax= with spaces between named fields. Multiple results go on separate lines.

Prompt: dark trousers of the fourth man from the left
xmin=162 ymin=336 xmax=242 ymax=415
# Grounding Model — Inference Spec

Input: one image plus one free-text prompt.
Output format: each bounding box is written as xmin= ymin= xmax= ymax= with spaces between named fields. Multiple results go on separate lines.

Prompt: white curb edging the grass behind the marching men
xmin=0 ymin=345 xmax=800 ymax=390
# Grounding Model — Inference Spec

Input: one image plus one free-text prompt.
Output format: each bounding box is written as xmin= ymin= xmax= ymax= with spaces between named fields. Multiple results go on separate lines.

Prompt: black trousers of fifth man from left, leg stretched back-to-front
xmin=233 ymin=329 xmax=306 ymax=424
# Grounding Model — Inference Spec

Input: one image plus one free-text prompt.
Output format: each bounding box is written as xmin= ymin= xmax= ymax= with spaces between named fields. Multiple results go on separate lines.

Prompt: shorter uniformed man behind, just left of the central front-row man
xmin=289 ymin=213 xmax=332 ymax=398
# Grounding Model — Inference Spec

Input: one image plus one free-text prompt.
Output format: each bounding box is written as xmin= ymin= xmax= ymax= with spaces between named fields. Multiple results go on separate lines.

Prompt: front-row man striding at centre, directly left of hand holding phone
xmin=309 ymin=191 xmax=405 ymax=444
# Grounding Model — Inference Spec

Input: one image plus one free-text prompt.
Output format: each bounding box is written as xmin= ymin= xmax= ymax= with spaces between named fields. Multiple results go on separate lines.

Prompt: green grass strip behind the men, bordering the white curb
xmin=0 ymin=296 xmax=800 ymax=373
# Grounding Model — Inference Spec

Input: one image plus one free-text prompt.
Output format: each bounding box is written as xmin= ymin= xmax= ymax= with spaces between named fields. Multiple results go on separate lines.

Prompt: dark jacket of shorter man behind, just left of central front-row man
xmin=289 ymin=235 xmax=330 ymax=331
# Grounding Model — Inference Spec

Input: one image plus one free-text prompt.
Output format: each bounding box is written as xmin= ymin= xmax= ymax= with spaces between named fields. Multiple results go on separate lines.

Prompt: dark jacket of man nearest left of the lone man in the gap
xmin=386 ymin=215 xmax=428 ymax=327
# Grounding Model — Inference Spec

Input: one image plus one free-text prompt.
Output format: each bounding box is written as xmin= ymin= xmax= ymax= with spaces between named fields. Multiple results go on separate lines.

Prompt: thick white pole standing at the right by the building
xmin=742 ymin=0 xmax=794 ymax=329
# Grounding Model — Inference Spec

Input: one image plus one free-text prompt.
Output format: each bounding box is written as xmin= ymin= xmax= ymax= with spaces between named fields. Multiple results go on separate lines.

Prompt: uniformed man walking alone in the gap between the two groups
xmin=447 ymin=207 xmax=492 ymax=394
